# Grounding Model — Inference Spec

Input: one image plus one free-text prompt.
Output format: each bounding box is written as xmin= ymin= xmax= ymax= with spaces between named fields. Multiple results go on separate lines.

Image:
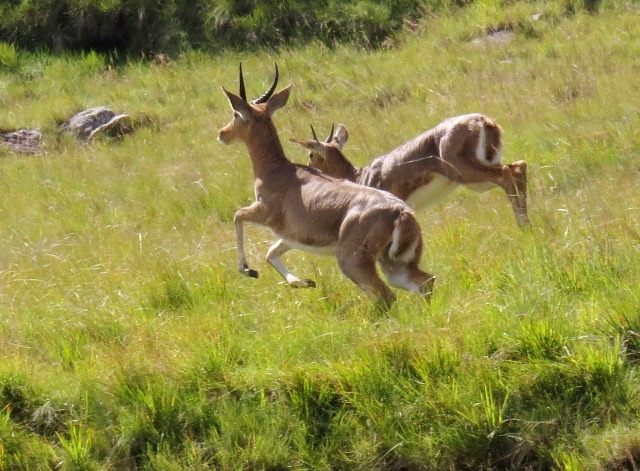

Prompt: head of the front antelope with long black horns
xmin=218 ymin=64 xmax=293 ymax=144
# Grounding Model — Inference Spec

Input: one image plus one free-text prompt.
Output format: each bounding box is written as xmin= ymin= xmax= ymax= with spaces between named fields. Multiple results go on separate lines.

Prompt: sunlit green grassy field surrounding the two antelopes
xmin=0 ymin=1 xmax=640 ymax=470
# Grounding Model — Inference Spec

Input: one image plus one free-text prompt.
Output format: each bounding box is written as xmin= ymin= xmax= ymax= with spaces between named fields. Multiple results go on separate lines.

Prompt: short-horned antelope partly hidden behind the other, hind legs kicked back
xmin=296 ymin=117 xmax=529 ymax=227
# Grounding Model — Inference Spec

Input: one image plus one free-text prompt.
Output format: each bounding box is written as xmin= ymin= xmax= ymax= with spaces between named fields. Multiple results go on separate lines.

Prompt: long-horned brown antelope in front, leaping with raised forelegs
xmin=218 ymin=65 xmax=435 ymax=310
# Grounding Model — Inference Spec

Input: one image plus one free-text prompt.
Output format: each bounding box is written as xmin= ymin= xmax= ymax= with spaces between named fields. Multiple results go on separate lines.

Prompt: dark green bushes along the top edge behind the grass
xmin=0 ymin=0 xmax=430 ymax=55
